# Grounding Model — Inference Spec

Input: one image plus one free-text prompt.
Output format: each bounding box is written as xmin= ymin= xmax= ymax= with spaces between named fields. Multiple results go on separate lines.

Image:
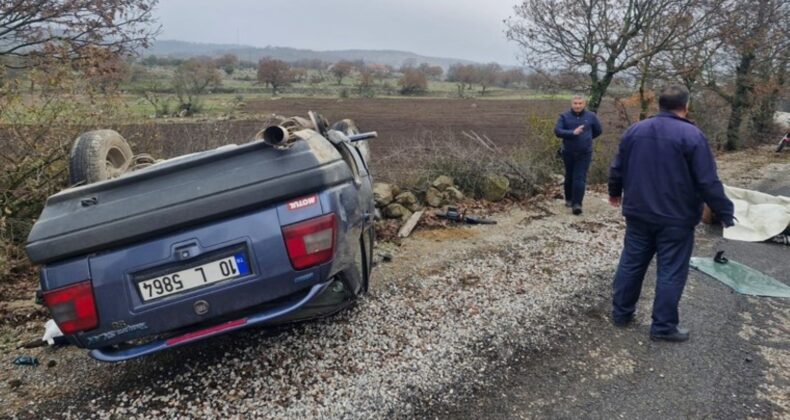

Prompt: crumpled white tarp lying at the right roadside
xmin=724 ymin=185 xmax=790 ymax=242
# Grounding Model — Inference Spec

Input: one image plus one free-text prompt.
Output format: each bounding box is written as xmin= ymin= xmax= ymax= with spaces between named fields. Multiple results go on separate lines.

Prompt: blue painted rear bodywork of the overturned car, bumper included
xmin=41 ymin=132 xmax=374 ymax=361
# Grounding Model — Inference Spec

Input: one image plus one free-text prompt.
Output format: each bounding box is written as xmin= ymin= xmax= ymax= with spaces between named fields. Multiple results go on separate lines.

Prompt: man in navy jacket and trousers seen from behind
xmin=609 ymin=86 xmax=734 ymax=342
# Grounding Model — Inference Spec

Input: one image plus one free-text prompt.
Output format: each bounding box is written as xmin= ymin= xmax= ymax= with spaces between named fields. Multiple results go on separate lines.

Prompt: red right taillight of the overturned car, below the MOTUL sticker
xmin=283 ymin=213 xmax=337 ymax=270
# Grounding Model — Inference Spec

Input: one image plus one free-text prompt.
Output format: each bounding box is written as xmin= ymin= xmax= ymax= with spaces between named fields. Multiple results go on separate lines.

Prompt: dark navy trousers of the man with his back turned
xmin=612 ymin=219 xmax=694 ymax=334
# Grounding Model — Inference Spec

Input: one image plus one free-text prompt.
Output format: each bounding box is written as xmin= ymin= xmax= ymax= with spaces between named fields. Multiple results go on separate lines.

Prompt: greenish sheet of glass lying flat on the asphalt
xmin=691 ymin=257 xmax=790 ymax=297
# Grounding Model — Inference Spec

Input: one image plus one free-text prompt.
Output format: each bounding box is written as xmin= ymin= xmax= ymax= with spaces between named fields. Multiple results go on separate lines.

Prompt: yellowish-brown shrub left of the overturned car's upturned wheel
xmin=0 ymin=67 xmax=133 ymax=278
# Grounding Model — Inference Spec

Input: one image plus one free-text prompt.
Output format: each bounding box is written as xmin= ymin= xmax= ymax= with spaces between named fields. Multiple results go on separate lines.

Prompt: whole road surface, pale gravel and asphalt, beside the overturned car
xmin=0 ymin=146 xmax=790 ymax=419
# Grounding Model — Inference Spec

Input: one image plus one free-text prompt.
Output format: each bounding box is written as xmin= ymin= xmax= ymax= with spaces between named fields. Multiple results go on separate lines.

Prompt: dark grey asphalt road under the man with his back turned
xmin=423 ymin=146 xmax=790 ymax=419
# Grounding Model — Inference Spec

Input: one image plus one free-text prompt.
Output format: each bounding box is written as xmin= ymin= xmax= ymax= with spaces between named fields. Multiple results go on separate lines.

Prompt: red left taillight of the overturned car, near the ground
xmin=44 ymin=280 xmax=99 ymax=335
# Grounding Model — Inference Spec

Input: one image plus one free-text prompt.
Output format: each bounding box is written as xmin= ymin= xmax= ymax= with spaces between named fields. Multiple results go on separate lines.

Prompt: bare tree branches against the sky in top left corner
xmin=0 ymin=0 xmax=159 ymax=69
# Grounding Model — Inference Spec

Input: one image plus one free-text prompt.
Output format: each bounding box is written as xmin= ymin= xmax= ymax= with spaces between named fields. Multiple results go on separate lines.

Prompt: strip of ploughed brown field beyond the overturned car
xmin=108 ymin=98 xmax=623 ymax=157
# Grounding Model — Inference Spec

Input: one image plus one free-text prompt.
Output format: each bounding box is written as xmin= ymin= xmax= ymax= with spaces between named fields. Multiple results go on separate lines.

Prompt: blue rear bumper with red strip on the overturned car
xmin=89 ymin=281 xmax=333 ymax=362
